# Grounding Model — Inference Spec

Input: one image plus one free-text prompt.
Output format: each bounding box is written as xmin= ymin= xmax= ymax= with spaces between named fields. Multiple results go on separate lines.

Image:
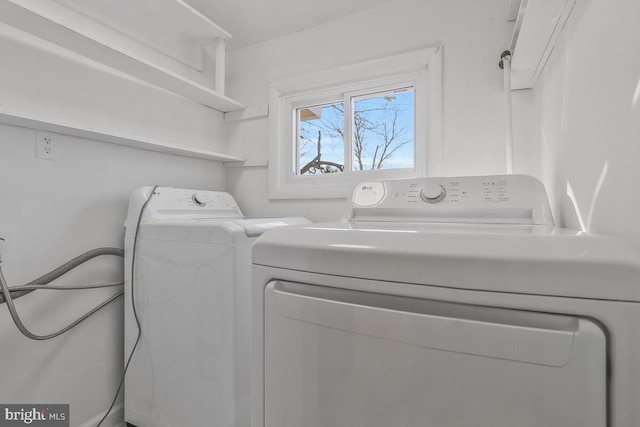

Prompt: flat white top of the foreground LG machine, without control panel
xmin=253 ymin=222 xmax=640 ymax=301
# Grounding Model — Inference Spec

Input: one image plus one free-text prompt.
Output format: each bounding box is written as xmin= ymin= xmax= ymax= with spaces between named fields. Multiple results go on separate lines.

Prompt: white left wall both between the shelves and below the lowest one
xmin=0 ymin=22 xmax=225 ymax=426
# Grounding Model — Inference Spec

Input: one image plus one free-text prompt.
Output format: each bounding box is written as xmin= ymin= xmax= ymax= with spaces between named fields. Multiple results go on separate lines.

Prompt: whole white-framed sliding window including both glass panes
xmin=269 ymin=48 xmax=441 ymax=198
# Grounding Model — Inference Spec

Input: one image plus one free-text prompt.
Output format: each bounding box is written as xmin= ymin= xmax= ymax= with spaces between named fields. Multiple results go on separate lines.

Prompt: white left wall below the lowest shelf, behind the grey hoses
xmin=0 ymin=125 xmax=225 ymax=426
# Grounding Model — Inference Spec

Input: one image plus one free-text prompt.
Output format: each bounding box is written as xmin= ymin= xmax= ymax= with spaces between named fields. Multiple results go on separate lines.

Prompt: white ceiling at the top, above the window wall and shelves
xmin=185 ymin=0 xmax=396 ymax=50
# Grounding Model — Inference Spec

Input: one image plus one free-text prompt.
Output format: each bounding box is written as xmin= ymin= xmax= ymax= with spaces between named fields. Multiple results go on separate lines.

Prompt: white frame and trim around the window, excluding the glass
xmin=268 ymin=46 xmax=442 ymax=199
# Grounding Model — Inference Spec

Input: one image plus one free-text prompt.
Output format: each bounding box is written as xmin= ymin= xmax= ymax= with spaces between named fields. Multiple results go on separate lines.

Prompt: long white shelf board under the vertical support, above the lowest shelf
xmin=0 ymin=0 xmax=244 ymax=112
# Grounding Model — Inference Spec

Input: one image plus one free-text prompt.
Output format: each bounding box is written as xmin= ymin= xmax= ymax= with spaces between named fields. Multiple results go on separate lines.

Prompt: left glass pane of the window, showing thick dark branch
xmin=296 ymin=102 xmax=344 ymax=175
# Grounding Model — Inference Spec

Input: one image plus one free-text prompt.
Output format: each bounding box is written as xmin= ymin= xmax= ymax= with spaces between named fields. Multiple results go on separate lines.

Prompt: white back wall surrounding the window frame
xmin=227 ymin=0 xmax=520 ymax=220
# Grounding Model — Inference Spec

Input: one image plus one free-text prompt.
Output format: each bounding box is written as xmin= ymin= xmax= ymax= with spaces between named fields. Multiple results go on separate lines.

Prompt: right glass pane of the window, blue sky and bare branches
xmin=352 ymin=88 xmax=415 ymax=170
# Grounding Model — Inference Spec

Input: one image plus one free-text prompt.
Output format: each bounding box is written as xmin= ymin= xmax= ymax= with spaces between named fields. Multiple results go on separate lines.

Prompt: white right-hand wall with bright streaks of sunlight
xmin=534 ymin=0 xmax=640 ymax=246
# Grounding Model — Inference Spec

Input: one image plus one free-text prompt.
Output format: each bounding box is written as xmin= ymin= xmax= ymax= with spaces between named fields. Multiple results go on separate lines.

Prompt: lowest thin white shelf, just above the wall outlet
xmin=0 ymin=108 xmax=244 ymax=162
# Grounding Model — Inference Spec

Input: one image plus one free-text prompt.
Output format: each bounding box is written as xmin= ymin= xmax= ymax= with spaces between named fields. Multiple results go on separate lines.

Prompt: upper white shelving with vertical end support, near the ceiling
xmin=0 ymin=0 xmax=244 ymax=112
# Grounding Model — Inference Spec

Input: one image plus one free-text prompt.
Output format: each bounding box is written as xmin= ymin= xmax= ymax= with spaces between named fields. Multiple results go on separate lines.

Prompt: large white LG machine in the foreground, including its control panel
xmin=253 ymin=175 xmax=640 ymax=427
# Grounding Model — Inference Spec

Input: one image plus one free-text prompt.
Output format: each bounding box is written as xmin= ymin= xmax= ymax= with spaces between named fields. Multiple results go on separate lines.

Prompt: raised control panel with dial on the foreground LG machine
xmin=349 ymin=175 xmax=553 ymax=225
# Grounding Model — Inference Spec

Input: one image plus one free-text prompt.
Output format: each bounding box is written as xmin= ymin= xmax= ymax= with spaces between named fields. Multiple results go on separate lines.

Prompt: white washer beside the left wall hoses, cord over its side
xmin=125 ymin=187 xmax=309 ymax=427
